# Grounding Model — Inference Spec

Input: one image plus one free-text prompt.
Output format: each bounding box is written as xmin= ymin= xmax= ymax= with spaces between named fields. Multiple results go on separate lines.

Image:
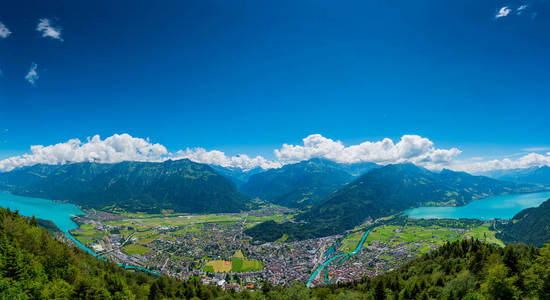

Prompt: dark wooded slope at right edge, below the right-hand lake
xmin=497 ymin=199 xmax=550 ymax=247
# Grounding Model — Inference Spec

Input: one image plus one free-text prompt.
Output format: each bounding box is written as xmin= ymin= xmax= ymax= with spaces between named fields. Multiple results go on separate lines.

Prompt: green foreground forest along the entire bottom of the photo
xmin=0 ymin=209 xmax=550 ymax=299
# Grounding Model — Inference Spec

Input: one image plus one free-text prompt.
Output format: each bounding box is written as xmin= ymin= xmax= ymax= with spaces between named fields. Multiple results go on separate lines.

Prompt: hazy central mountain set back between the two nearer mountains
xmin=241 ymin=159 xmax=362 ymax=207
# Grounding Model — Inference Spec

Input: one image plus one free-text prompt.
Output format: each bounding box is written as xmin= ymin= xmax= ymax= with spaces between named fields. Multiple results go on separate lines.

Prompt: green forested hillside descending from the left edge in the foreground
xmin=0 ymin=208 xmax=226 ymax=299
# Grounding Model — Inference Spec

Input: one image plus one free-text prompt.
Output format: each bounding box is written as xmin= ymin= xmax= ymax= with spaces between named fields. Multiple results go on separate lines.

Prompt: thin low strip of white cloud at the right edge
xmin=452 ymin=153 xmax=550 ymax=173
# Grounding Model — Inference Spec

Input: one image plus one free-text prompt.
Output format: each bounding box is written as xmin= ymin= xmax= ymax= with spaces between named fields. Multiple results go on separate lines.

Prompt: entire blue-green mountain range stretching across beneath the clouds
xmin=0 ymin=159 xmax=547 ymax=241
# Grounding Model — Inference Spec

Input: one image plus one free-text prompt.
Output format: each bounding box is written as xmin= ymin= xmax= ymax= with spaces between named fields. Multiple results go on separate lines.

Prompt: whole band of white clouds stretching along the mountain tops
xmin=0 ymin=130 xmax=550 ymax=173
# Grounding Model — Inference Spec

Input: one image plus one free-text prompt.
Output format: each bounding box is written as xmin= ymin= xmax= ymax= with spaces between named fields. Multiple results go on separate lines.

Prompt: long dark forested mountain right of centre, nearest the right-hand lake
xmin=248 ymin=164 xmax=533 ymax=240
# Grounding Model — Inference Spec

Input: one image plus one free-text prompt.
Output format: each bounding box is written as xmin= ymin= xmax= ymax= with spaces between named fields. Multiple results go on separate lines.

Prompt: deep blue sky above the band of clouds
xmin=0 ymin=0 xmax=550 ymax=171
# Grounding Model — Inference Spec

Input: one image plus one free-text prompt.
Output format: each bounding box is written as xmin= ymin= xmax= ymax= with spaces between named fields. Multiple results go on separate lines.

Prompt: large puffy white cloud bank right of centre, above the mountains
xmin=275 ymin=134 xmax=461 ymax=169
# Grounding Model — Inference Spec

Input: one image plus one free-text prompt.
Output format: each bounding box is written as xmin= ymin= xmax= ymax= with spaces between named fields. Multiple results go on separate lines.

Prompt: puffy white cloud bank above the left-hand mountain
xmin=0 ymin=134 xmax=168 ymax=171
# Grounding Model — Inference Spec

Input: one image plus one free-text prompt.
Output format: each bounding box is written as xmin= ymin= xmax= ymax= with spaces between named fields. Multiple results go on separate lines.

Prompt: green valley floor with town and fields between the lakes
xmin=67 ymin=206 xmax=503 ymax=289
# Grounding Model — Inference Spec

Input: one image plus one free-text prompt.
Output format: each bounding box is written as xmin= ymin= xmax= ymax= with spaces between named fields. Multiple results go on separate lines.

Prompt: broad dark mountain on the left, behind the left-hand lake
xmin=0 ymin=160 xmax=248 ymax=213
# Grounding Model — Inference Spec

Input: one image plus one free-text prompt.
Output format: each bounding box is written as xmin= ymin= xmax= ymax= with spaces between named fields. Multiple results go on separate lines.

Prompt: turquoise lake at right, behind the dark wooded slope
xmin=405 ymin=192 xmax=550 ymax=220
